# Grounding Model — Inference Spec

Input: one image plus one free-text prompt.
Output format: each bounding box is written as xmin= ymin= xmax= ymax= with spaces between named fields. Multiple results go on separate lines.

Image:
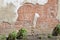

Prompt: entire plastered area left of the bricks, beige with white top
xmin=0 ymin=0 xmax=24 ymax=24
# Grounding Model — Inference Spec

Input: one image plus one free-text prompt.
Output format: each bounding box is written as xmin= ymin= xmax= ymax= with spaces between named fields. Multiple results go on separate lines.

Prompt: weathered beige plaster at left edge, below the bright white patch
xmin=0 ymin=3 xmax=18 ymax=24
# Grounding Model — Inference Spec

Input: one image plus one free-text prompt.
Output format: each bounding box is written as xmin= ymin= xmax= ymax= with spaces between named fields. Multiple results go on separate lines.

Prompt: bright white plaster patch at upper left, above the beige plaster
xmin=4 ymin=0 xmax=24 ymax=12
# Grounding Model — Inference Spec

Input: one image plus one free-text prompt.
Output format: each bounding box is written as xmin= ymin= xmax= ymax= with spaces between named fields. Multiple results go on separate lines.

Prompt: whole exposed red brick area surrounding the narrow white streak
xmin=0 ymin=0 xmax=58 ymax=34
